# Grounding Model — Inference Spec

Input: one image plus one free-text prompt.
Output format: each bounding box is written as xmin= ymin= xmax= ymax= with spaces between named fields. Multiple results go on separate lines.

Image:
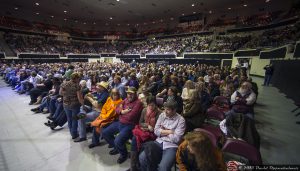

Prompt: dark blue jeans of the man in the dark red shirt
xmin=102 ymin=121 xmax=134 ymax=156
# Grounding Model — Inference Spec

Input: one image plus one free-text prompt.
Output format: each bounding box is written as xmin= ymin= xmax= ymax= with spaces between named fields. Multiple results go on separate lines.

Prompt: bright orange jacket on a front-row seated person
xmin=91 ymin=97 xmax=122 ymax=131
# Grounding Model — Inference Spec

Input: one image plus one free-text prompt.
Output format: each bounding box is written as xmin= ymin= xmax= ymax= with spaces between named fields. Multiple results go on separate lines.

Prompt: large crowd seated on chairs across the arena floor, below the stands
xmin=0 ymin=59 xmax=259 ymax=170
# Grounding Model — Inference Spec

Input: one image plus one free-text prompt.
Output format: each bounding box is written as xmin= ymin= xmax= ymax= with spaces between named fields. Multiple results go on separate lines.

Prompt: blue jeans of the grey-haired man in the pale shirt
xmin=139 ymin=141 xmax=177 ymax=171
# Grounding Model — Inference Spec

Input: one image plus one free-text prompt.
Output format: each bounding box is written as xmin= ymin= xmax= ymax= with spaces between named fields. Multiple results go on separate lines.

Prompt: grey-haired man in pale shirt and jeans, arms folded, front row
xmin=139 ymin=100 xmax=185 ymax=171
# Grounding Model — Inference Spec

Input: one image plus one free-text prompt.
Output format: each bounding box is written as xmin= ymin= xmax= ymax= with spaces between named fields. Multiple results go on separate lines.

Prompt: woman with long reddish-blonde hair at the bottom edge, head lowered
xmin=176 ymin=132 xmax=226 ymax=171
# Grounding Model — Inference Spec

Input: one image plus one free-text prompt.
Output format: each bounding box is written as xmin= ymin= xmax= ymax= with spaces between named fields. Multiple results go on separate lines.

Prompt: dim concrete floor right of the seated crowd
xmin=253 ymin=78 xmax=300 ymax=164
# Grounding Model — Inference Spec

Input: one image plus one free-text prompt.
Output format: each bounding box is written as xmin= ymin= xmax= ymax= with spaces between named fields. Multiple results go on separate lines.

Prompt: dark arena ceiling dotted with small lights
xmin=0 ymin=0 xmax=292 ymax=30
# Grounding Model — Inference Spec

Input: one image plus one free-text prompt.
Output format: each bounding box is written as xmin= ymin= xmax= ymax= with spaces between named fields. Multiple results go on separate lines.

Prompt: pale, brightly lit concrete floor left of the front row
xmin=0 ymin=79 xmax=129 ymax=171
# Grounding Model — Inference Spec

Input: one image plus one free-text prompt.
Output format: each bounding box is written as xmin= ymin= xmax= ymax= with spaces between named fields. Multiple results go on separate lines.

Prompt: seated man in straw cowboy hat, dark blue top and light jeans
xmin=74 ymin=81 xmax=109 ymax=142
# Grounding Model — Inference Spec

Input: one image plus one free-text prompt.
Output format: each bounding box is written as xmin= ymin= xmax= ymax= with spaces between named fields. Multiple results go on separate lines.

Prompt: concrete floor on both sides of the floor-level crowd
xmin=0 ymin=78 xmax=300 ymax=171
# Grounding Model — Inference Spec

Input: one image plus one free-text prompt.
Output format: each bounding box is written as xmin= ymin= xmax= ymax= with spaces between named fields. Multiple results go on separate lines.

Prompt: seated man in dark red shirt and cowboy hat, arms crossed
xmin=102 ymin=87 xmax=143 ymax=164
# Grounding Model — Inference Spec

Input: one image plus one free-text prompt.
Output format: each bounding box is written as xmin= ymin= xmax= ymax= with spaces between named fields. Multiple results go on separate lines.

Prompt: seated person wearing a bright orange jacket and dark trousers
xmin=89 ymin=88 xmax=122 ymax=148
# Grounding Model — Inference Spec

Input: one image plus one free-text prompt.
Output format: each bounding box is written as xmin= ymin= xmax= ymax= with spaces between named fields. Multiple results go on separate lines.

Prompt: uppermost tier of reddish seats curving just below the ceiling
xmin=0 ymin=7 xmax=299 ymax=38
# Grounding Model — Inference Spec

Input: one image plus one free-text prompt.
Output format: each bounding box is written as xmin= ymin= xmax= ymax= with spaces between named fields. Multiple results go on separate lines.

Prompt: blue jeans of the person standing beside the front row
xmin=64 ymin=105 xmax=80 ymax=138
